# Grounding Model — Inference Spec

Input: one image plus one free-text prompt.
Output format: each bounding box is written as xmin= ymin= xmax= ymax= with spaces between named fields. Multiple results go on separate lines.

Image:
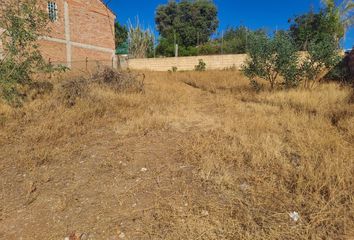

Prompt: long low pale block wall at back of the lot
xmin=127 ymin=54 xmax=247 ymax=71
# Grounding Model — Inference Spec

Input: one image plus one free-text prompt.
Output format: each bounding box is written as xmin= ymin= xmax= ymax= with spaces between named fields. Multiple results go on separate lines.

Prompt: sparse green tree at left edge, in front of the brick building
xmin=0 ymin=0 xmax=49 ymax=106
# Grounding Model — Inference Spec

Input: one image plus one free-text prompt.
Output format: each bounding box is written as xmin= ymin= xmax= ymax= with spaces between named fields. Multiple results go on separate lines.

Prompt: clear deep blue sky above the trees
xmin=106 ymin=0 xmax=354 ymax=48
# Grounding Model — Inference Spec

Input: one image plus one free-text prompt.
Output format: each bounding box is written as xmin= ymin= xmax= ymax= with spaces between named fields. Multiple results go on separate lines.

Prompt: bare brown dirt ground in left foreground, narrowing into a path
xmin=0 ymin=78 xmax=221 ymax=240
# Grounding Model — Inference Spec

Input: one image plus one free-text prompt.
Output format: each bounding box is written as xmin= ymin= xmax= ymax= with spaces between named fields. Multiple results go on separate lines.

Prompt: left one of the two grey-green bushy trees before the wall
xmin=242 ymin=33 xmax=298 ymax=89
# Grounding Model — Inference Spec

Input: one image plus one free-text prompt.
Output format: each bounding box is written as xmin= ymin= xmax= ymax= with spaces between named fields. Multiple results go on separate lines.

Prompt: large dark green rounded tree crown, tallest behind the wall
xmin=155 ymin=0 xmax=219 ymax=47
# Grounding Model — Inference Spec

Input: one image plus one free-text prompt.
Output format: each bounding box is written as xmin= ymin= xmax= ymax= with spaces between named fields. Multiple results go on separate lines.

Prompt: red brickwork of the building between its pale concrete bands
xmin=0 ymin=0 xmax=115 ymax=64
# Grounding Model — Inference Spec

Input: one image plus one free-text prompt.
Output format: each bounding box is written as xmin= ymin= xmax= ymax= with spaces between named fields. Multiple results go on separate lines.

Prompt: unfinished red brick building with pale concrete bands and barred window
xmin=0 ymin=0 xmax=116 ymax=68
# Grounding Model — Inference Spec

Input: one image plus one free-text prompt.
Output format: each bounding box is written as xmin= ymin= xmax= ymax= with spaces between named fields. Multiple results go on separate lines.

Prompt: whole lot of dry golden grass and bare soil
xmin=0 ymin=71 xmax=354 ymax=240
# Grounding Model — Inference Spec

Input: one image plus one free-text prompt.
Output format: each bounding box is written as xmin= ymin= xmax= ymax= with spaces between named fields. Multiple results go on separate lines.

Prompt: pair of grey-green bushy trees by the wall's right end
xmin=243 ymin=33 xmax=340 ymax=89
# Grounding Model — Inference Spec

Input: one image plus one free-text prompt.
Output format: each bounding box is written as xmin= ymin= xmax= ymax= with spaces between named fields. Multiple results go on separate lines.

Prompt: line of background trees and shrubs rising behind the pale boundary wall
xmin=116 ymin=0 xmax=354 ymax=57
